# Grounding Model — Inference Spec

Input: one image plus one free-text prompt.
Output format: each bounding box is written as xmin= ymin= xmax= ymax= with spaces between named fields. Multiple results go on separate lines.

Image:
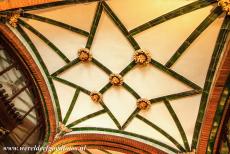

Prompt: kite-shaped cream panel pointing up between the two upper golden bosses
xmin=91 ymin=13 xmax=134 ymax=73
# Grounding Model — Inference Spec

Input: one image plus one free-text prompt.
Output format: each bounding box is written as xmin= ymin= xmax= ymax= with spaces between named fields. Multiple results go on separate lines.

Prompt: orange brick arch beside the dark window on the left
xmin=0 ymin=23 xmax=56 ymax=142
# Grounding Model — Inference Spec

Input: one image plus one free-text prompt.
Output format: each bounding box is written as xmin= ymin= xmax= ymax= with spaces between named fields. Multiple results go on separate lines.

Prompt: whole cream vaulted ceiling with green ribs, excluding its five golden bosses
xmin=2 ymin=0 xmax=230 ymax=153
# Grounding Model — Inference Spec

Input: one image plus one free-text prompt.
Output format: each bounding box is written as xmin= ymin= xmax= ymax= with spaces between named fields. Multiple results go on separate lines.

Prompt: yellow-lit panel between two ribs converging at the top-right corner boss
xmin=134 ymin=6 xmax=213 ymax=64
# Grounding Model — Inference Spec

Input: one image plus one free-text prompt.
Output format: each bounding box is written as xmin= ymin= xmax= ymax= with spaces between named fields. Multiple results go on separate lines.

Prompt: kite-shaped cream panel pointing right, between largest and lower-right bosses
xmin=124 ymin=65 xmax=191 ymax=99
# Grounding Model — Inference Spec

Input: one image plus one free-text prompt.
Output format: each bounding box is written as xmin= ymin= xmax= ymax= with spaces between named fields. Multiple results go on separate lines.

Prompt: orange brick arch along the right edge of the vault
xmin=197 ymin=42 xmax=230 ymax=154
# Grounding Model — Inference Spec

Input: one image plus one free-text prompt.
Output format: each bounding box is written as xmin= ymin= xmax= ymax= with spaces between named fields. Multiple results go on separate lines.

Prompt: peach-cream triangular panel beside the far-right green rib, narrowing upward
xmin=172 ymin=16 xmax=224 ymax=87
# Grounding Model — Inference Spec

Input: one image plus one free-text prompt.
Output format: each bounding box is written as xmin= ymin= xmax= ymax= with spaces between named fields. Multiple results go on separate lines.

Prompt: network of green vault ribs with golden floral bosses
xmin=0 ymin=0 xmax=230 ymax=153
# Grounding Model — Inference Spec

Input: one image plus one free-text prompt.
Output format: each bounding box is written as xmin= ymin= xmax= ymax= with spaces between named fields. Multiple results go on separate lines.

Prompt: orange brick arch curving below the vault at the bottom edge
xmin=51 ymin=133 xmax=166 ymax=154
